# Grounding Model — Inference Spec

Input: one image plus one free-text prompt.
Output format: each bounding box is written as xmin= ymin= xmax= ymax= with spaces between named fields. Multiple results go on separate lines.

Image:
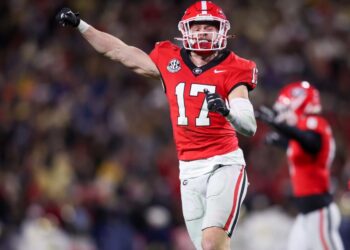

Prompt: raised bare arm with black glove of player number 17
xmin=56 ymin=8 xmax=160 ymax=78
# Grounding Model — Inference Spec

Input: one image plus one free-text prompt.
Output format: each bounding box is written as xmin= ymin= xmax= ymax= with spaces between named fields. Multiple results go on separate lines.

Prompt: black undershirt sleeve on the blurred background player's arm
xmin=272 ymin=123 xmax=322 ymax=155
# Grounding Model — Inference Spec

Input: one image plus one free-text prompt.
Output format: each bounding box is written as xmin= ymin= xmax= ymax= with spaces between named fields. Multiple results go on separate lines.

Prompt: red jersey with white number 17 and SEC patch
xmin=150 ymin=41 xmax=257 ymax=161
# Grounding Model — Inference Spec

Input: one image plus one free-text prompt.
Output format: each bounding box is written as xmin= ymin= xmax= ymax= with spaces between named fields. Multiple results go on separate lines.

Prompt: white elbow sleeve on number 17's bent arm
xmin=226 ymin=98 xmax=256 ymax=136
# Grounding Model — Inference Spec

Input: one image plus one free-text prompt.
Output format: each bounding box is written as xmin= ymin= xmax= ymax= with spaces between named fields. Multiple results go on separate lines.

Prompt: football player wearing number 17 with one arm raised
xmin=57 ymin=1 xmax=257 ymax=250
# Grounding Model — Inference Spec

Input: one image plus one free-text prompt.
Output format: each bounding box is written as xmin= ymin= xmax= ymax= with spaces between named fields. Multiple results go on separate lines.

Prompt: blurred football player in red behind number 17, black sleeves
xmin=255 ymin=81 xmax=344 ymax=250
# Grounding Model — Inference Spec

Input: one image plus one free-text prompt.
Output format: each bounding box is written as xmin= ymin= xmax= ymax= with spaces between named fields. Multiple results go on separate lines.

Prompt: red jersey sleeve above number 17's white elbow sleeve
xmin=225 ymin=61 xmax=258 ymax=93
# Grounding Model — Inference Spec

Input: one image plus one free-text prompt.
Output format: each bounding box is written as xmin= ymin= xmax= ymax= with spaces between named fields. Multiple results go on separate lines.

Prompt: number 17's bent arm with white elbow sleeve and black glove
xmin=205 ymin=85 xmax=256 ymax=136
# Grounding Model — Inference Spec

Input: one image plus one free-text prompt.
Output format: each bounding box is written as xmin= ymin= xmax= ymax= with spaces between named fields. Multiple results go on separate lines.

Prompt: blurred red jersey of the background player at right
xmin=287 ymin=115 xmax=335 ymax=197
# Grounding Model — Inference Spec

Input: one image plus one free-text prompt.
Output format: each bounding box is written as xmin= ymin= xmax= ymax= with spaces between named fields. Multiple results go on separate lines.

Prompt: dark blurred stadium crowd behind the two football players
xmin=0 ymin=0 xmax=350 ymax=250
